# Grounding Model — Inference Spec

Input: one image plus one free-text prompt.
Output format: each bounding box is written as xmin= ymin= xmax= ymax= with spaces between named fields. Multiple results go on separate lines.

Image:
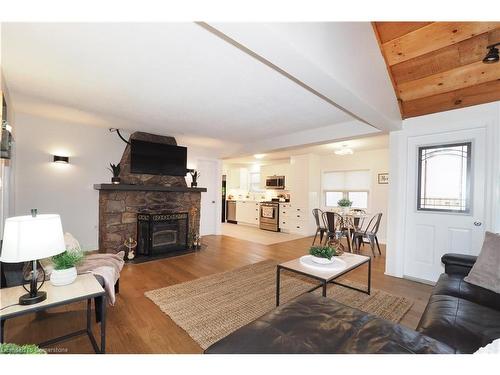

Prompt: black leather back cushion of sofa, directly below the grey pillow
xmin=432 ymin=273 xmax=500 ymax=310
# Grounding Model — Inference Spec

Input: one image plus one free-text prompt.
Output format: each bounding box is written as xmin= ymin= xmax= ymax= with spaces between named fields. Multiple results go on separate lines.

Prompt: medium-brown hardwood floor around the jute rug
xmin=0 ymin=236 xmax=432 ymax=353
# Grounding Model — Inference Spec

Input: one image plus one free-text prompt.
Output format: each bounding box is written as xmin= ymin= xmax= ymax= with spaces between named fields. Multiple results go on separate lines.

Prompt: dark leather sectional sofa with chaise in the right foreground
xmin=205 ymin=254 xmax=500 ymax=354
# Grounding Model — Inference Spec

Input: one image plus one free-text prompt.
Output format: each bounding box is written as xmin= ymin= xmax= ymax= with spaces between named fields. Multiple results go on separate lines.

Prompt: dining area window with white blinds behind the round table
xmin=322 ymin=170 xmax=371 ymax=209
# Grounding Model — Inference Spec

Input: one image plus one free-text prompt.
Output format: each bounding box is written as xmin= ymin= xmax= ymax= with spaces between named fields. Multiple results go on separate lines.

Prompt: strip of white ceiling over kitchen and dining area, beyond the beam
xmin=224 ymin=134 xmax=389 ymax=164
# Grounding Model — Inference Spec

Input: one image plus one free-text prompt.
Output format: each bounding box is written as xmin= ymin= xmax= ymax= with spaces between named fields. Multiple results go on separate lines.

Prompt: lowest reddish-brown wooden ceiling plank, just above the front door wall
xmin=402 ymin=80 xmax=500 ymax=118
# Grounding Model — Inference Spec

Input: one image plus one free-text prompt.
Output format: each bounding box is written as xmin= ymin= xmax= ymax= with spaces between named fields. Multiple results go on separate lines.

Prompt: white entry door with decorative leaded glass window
xmin=404 ymin=128 xmax=486 ymax=281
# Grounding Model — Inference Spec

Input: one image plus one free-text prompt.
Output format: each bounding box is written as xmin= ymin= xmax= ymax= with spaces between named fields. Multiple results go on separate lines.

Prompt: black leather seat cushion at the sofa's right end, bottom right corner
xmin=417 ymin=295 xmax=500 ymax=353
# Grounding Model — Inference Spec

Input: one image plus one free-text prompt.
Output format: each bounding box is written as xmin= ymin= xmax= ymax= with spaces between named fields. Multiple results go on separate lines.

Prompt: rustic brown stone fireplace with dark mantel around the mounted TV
xmin=94 ymin=132 xmax=206 ymax=256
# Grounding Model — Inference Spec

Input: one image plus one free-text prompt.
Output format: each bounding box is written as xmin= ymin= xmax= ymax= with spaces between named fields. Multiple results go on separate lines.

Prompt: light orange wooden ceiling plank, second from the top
xmin=382 ymin=22 xmax=500 ymax=66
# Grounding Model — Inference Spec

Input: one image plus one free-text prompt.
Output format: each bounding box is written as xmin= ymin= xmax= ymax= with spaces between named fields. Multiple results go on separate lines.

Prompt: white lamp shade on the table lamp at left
xmin=0 ymin=214 xmax=66 ymax=263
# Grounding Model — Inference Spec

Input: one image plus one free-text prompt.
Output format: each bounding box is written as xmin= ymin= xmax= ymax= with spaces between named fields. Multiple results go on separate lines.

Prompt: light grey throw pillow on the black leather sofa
xmin=464 ymin=232 xmax=500 ymax=293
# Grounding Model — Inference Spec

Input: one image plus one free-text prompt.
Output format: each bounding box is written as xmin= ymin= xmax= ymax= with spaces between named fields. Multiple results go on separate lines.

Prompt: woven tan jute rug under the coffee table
xmin=145 ymin=260 xmax=413 ymax=349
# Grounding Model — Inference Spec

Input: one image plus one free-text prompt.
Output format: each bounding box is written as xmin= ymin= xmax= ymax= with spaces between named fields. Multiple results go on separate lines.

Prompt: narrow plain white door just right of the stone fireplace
xmin=197 ymin=159 xmax=220 ymax=236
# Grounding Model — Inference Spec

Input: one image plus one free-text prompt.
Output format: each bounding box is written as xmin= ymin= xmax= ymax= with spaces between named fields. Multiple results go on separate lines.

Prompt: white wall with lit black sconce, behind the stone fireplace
xmin=15 ymin=113 xmax=221 ymax=250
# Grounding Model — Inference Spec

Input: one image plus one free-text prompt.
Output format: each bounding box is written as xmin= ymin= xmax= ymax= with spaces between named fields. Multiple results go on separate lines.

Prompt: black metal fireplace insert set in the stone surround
xmin=137 ymin=212 xmax=189 ymax=256
